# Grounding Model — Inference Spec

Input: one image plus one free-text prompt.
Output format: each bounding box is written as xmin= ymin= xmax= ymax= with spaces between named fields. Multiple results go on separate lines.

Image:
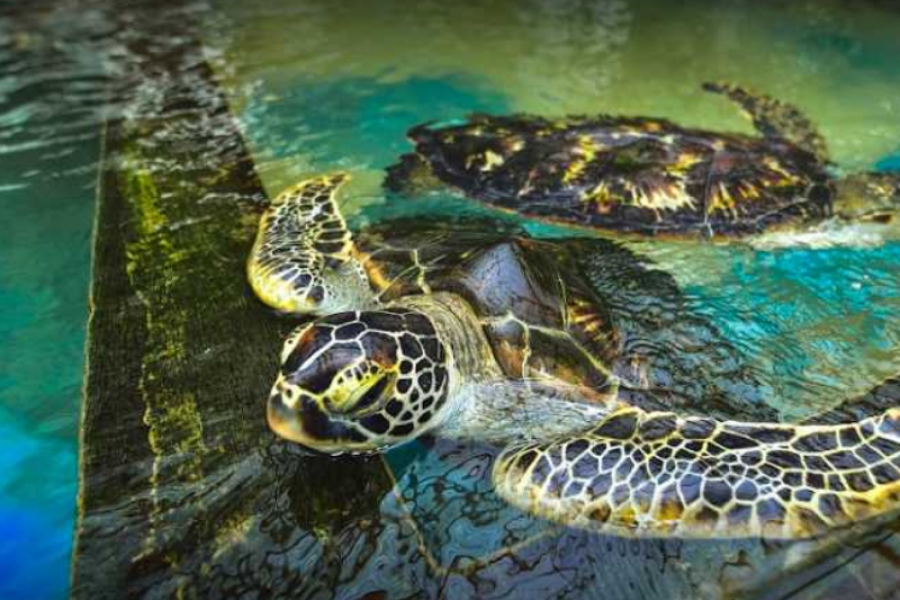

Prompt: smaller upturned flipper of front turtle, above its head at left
xmin=247 ymin=173 xmax=368 ymax=314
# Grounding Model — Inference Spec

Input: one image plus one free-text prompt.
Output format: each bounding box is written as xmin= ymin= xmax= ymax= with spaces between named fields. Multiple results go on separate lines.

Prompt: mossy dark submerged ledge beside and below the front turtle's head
xmin=72 ymin=2 xmax=900 ymax=599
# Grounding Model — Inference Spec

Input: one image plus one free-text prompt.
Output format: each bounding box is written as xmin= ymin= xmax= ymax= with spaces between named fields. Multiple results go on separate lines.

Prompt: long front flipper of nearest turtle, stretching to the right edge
xmin=494 ymin=408 xmax=900 ymax=539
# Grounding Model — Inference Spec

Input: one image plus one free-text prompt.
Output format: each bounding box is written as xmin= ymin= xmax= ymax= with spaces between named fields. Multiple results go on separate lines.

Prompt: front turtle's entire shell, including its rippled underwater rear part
xmin=354 ymin=218 xmax=777 ymax=419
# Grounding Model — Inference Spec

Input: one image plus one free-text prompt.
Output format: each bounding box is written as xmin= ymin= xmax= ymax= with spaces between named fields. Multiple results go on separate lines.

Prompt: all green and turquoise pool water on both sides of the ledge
xmin=0 ymin=0 xmax=900 ymax=598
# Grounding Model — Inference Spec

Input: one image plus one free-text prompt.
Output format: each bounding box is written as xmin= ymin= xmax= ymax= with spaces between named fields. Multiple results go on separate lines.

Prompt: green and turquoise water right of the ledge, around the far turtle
xmin=210 ymin=0 xmax=900 ymax=418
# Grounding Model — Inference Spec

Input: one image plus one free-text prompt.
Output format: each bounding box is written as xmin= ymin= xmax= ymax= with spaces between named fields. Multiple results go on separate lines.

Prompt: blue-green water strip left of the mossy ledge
xmin=0 ymin=3 xmax=103 ymax=598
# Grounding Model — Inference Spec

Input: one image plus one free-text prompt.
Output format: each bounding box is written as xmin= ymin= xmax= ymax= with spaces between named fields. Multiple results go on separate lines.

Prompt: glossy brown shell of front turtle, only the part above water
xmin=355 ymin=219 xmax=618 ymax=400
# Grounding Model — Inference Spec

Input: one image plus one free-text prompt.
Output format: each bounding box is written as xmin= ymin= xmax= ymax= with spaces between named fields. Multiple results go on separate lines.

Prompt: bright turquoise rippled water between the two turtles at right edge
xmin=647 ymin=242 xmax=900 ymax=418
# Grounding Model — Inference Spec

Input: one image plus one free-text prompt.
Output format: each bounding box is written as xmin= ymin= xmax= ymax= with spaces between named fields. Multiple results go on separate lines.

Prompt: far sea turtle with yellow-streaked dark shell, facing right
xmin=385 ymin=83 xmax=900 ymax=236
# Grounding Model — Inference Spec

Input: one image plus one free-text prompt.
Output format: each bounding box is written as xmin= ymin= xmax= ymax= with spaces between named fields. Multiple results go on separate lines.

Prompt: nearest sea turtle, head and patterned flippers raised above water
xmin=248 ymin=175 xmax=900 ymax=538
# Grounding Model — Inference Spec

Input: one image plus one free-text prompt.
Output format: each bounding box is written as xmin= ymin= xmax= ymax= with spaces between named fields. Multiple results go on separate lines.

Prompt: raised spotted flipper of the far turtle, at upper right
xmin=703 ymin=81 xmax=828 ymax=162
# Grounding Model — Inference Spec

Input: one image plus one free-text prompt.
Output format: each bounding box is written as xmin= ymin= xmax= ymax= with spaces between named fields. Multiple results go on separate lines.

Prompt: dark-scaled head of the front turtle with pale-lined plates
xmin=268 ymin=309 xmax=450 ymax=454
